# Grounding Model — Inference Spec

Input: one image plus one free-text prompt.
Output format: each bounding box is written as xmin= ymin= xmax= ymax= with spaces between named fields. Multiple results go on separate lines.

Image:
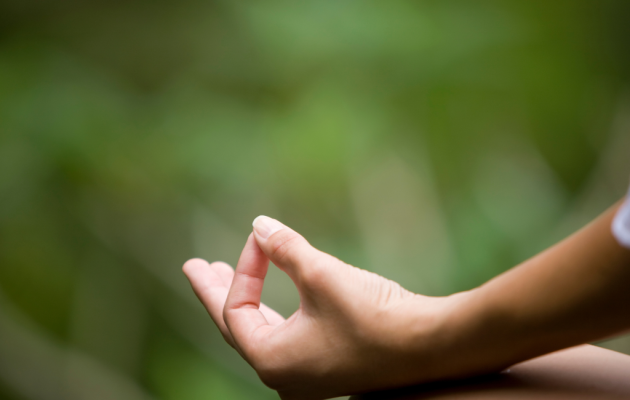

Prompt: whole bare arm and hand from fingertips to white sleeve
xmin=184 ymin=206 xmax=630 ymax=400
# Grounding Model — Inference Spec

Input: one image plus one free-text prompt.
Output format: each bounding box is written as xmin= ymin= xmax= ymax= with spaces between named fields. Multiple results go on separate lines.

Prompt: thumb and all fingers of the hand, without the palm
xmin=184 ymin=216 xmax=331 ymax=354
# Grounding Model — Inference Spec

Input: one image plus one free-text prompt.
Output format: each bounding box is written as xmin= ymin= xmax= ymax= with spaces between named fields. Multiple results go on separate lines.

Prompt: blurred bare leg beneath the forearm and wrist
xmin=350 ymin=345 xmax=630 ymax=400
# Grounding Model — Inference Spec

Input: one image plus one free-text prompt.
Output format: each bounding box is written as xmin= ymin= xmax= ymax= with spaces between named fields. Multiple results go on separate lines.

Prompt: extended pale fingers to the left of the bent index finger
xmin=183 ymin=258 xmax=234 ymax=347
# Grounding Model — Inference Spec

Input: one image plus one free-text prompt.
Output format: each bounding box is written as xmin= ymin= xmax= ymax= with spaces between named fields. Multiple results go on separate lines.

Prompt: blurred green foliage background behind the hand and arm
xmin=0 ymin=0 xmax=630 ymax=400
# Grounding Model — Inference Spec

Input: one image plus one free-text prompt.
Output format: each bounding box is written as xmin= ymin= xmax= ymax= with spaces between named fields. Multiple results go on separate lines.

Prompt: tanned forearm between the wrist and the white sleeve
xmin=441 ymin=202 xmax=630 ymax=376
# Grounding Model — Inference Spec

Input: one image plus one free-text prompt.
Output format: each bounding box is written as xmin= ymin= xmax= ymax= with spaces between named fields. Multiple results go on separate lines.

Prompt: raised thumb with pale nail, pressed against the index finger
xmin=253 ymin=215 xmax=343 ymax=287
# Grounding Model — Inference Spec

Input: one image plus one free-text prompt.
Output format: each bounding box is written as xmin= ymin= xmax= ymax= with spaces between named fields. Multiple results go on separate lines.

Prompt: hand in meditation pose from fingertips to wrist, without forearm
xmin=183 ymin=217 xmax=464 ymax=399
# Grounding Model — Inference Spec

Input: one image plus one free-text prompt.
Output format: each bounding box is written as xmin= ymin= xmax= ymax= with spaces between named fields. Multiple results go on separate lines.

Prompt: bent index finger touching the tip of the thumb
xmin=223 ymin=234 xmax=282 ymax=355
